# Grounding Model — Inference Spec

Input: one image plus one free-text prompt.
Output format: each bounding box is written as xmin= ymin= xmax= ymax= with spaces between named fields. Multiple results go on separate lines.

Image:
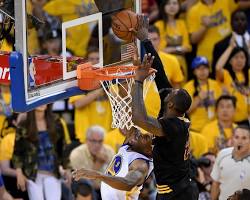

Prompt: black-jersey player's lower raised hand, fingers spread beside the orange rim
xmin=135 ymin=53 xmax=156 ymax=82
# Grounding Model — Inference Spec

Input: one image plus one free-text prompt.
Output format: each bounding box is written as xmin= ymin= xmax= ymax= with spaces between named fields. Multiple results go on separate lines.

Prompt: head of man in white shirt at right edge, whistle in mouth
xmin=233 ymin=125 xmax=250 ymax=153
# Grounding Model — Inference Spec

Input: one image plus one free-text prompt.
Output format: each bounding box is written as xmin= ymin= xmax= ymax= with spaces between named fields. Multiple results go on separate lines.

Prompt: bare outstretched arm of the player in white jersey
xmin=73 ymin=160 xmax=149 ymax=191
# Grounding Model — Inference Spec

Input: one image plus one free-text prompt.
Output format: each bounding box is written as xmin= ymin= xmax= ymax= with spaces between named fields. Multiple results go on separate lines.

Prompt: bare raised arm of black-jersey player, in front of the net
xmin=132 ymin=54 xmax=163 ymax=136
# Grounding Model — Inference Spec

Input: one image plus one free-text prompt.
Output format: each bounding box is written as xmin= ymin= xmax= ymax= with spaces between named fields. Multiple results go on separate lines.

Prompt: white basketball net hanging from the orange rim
xmin=101 ymin=72 xmax=155 ymax=130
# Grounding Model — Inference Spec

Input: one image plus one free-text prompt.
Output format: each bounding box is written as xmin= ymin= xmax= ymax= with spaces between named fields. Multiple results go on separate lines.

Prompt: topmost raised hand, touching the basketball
xmin=130 ymin=15 xmax=149 ymax=41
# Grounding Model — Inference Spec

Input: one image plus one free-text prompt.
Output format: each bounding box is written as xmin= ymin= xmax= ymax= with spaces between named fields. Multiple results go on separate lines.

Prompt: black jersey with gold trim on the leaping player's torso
xmin=153 ymin=117 xmax=189 ymax=194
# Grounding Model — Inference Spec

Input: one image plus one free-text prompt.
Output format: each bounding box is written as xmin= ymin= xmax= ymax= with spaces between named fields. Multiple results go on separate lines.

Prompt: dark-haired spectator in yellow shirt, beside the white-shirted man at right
xmin=201 ymin=95 xmax=236 ymax=153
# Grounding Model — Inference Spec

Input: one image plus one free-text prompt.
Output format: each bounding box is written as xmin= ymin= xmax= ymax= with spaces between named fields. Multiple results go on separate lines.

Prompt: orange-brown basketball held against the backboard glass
xmin=112 ymin=10 xmax=137 ymax=41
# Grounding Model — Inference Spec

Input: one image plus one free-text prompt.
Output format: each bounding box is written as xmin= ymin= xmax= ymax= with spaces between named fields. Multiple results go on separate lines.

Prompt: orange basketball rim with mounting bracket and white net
xmin=77 ymin=63 xmax=155 ymax=130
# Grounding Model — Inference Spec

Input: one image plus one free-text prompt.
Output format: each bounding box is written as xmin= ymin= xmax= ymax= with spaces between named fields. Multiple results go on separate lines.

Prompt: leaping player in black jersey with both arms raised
xmin=132 ymin=16 xmax=198 ymax=200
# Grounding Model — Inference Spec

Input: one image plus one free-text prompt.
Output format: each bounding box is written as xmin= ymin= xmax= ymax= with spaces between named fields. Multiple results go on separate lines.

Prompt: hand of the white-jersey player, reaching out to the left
xmin=72 ymin=168 xmax=101 ymax=181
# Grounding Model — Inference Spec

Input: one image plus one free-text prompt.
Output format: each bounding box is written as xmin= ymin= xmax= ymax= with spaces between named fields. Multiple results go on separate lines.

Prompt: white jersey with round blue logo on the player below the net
xmin=101 ymin=145 xmax=153 ymax=200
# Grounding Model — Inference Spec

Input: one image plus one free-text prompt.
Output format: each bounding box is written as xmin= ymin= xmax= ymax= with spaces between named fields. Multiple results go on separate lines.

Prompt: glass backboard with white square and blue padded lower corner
xmin=10 ymin=0 xmax=140 ymax=112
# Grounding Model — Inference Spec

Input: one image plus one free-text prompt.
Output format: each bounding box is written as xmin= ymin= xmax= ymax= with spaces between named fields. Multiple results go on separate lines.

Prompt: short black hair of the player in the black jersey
xmin=173 ymin=89 xmax=192 ymax=114
